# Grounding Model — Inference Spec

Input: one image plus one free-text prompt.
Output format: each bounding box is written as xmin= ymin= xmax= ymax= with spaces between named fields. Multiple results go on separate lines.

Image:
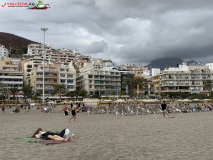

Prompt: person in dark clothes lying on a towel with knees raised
xmin=32 ymin=128 xmax=71 ymax=142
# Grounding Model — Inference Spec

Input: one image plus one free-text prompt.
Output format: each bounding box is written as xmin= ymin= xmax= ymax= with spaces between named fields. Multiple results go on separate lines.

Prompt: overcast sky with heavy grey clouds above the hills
xmin=0 ymin=0 xmax=213 ymax=64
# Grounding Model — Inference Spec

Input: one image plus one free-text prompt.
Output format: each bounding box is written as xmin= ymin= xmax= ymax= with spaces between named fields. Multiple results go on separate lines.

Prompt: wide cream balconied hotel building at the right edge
xmin=159 ymin=62 xmax=213 ymax=94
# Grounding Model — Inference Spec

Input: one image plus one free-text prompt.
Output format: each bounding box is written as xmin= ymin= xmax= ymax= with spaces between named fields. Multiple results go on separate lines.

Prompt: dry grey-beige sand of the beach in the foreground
xmin=0 ymin=105 xmax=213 ymax=160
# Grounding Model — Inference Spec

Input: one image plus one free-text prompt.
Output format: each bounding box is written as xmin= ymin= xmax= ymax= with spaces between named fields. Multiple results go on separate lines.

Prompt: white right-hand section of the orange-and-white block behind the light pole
xmin=59 ymin=63 xmax=76 ymax=91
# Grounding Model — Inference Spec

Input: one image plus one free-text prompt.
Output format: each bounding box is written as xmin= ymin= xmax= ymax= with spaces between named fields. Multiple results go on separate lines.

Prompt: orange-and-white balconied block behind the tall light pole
xmin=30 ymin=63 xmax=76 ymax=93
